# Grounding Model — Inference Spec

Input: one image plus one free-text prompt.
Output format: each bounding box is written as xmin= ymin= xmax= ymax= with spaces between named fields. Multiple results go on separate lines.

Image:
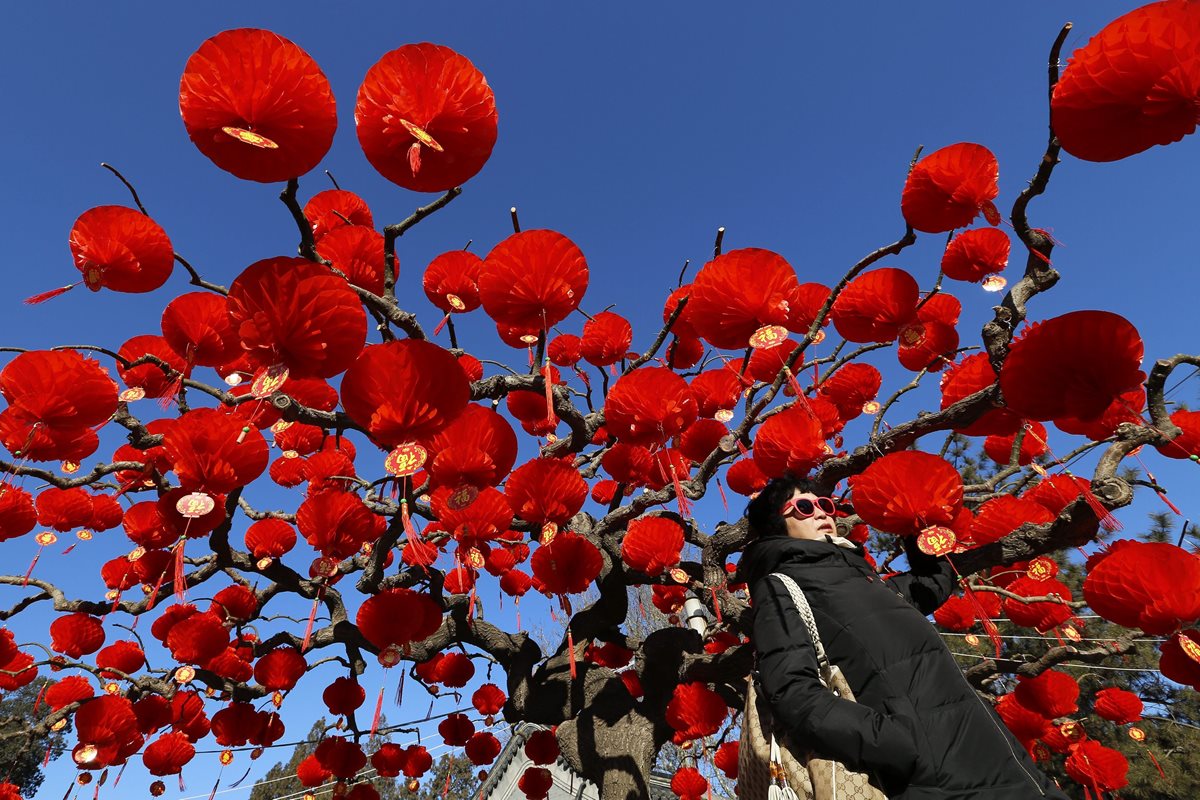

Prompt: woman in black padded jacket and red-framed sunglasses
xmin=742 ymin=477 xmax=1067 ymax=800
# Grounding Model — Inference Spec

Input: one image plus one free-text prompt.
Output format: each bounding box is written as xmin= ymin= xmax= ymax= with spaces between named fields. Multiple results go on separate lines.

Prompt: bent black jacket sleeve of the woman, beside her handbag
xmin=754 ymin=578 xmax=918 ymax=784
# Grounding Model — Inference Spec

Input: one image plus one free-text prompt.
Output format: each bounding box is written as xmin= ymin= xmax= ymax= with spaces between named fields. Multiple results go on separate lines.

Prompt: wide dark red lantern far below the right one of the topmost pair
xmin=342 ymin=339 xmax=470 ymax=449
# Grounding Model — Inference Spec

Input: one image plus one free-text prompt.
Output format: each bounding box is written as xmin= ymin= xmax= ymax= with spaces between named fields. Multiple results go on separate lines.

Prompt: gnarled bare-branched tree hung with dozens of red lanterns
xmin=0 ymin=1 xmax=1200 ymax=800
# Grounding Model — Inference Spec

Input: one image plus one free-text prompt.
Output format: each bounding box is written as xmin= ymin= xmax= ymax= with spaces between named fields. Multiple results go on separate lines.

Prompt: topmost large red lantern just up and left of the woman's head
xmin=686 ymin=247 xmax=799 ymax=350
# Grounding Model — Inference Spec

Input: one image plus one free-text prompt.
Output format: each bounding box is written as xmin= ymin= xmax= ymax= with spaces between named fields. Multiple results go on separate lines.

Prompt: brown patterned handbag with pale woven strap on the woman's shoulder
xmin=738 ymin=572 xmax=887 ymax=800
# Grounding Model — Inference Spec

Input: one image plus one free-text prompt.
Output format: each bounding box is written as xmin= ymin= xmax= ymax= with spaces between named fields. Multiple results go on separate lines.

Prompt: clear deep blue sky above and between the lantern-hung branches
xmin=0 ymin=0 xmax=1200 ymax=796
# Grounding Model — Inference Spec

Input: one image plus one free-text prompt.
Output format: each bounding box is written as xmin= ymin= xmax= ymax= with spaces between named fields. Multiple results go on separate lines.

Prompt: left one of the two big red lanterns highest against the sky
xmin=179 ymin=28 xmax=337 ymax=184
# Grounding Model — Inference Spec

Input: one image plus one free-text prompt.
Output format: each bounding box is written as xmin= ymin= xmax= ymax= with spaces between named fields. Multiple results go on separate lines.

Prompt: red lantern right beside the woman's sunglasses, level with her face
xmin=850 ymin=450 xmax=962 ymax=536
